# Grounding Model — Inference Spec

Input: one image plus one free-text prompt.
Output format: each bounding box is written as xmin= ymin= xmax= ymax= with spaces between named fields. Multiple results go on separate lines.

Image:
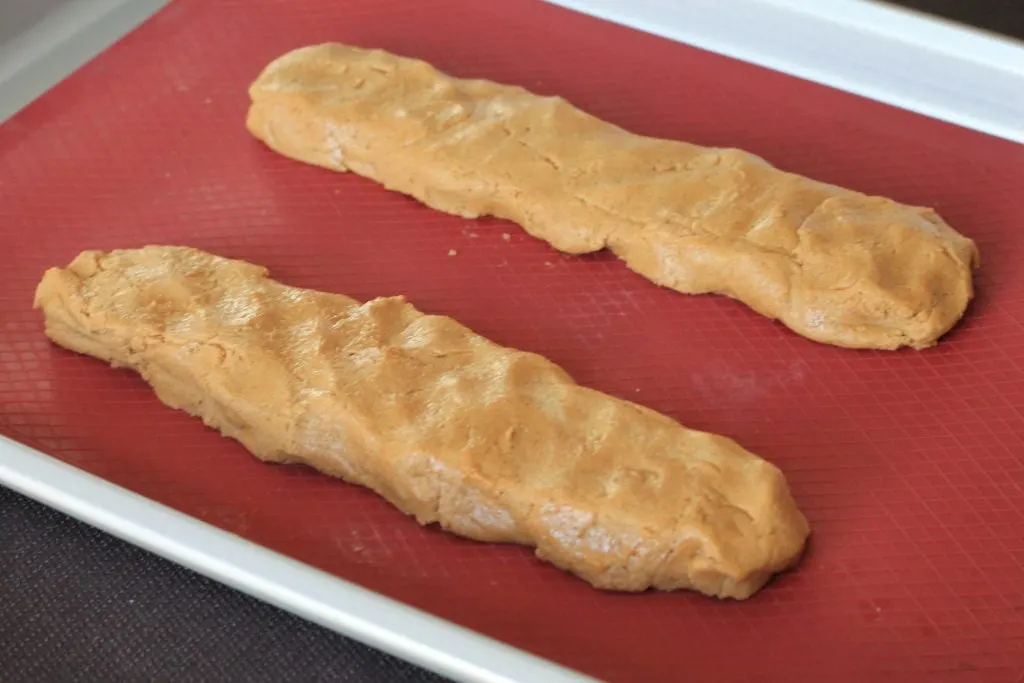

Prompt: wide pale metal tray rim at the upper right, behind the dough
xmin=547 ymin=0 xmax=1024 ymax=142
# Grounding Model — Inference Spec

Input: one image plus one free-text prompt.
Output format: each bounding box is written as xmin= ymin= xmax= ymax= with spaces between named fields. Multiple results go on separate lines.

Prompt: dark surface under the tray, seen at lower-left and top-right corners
xmin=0 ymin=0 xmax=1024 ymax=683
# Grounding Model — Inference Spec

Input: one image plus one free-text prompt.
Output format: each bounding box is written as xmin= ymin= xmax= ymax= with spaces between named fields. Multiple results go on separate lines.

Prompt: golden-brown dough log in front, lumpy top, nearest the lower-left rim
xmin=36 ymin=247 xmax=809 ymax=598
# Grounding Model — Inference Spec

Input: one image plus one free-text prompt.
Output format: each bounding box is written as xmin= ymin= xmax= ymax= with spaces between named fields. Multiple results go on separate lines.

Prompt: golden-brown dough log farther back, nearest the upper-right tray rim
xmin=247 ymin=44 xmax=978 ymax=349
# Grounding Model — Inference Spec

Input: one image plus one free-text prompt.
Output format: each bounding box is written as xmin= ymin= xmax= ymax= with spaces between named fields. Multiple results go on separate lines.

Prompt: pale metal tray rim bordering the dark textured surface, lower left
xmin=0 ymin=436 xmax=596 ymax=683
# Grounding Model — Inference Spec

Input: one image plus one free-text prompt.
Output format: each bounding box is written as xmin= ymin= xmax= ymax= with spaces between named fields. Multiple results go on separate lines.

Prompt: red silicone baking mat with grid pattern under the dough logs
xmin=0 ymin=0 xmax=1024 ymax=681
